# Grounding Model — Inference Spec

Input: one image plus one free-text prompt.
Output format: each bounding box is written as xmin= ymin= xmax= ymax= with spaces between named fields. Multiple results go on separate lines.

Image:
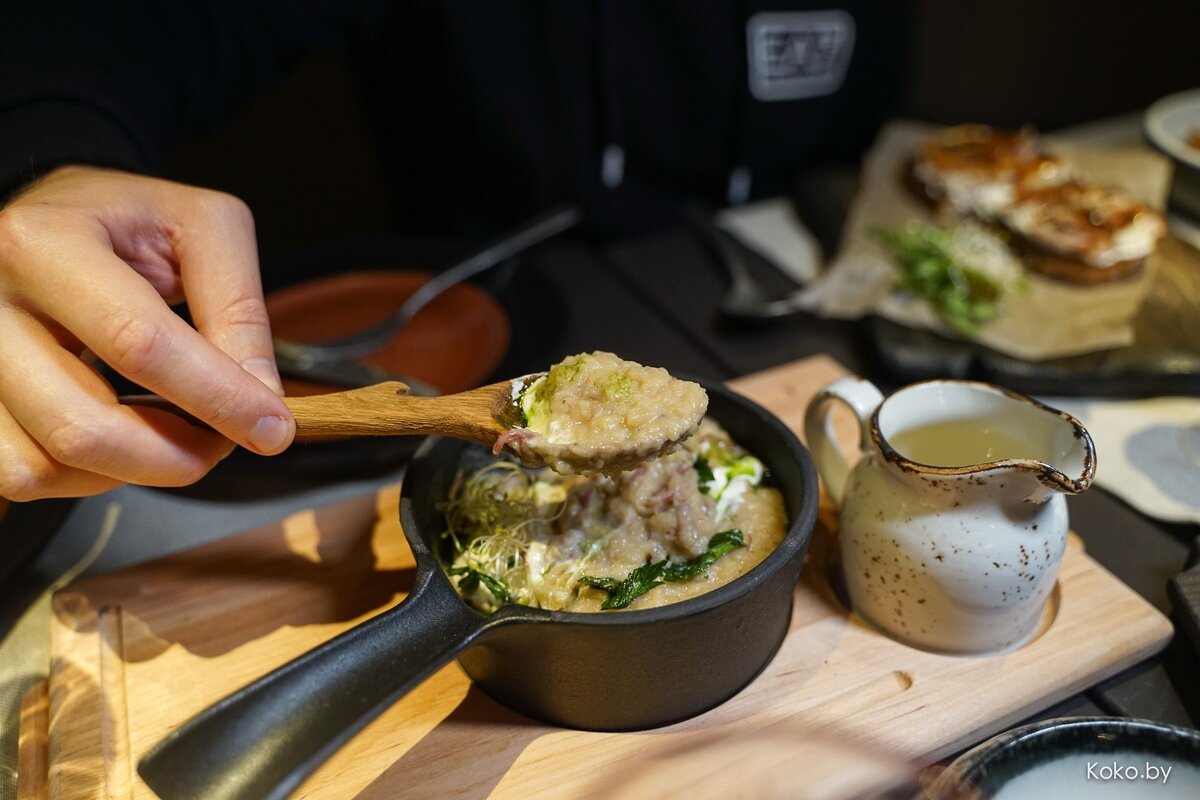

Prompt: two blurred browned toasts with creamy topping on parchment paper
xmin=911 ymin=125 xmax=1166 ymax=285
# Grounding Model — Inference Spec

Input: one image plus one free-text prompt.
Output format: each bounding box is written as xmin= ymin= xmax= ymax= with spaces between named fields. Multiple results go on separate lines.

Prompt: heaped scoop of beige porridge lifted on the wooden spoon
xmin=494 ymin=351 xmax=708 ymax=474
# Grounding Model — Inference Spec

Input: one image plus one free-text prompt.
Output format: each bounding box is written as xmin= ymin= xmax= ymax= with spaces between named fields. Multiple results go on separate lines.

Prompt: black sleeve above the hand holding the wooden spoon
xmin=0 ymin=0 xmax=384 ymax=197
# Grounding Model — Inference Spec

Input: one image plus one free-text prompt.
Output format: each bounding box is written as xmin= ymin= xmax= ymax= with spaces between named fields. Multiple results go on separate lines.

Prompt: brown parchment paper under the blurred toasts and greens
xmin=803 ymin=121 xmax=1171 ymax=361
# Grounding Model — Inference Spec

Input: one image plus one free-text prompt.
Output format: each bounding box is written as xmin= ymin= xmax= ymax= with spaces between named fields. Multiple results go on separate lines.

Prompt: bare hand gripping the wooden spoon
xmin=0 ymin=167 xmax=295 ymax=500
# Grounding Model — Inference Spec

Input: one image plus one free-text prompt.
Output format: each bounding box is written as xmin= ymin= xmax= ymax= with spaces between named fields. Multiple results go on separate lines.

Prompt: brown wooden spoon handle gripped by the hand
xmin=119 ymin=374 xmax=539 ymax=447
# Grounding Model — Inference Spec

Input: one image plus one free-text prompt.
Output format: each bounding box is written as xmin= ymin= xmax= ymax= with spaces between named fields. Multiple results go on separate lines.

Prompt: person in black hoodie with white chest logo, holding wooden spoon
xmin=0 ymin=0 xmax=908 ymax=500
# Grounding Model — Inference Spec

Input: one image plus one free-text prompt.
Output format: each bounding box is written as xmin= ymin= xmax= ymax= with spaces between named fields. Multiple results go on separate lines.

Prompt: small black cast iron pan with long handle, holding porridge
xmin=138 ymin=381 xmax=817 ymax=800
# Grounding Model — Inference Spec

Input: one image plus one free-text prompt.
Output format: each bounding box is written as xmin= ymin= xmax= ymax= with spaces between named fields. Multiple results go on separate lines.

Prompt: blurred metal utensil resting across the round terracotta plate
xmin=275 ymin=206 xmax=583 ymax=383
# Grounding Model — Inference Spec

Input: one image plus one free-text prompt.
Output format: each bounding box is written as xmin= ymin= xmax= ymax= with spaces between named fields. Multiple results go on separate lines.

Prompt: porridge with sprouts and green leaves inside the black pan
xmin=444 ymin=417 xmax=786 ymax=613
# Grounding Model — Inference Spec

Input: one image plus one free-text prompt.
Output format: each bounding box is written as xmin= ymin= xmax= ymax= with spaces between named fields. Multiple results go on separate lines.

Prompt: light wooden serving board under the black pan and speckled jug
xmin=22 ymin=357 xmax=1171 ymax=800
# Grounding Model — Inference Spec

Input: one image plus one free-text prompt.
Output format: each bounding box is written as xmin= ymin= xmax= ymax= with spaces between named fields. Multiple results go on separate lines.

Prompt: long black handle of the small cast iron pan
xmin=138 ymin=567 xmax=490 ymax=800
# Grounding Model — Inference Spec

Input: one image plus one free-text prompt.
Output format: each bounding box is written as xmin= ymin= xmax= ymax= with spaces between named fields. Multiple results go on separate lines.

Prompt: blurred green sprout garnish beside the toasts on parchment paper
xmin=872 ymin=222 xmax=1027 ymax=336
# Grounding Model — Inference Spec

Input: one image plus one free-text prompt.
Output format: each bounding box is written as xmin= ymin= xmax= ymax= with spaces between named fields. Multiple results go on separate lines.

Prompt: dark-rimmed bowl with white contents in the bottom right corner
xmin=923 ymin=717 xmax=1200 ymax=800
